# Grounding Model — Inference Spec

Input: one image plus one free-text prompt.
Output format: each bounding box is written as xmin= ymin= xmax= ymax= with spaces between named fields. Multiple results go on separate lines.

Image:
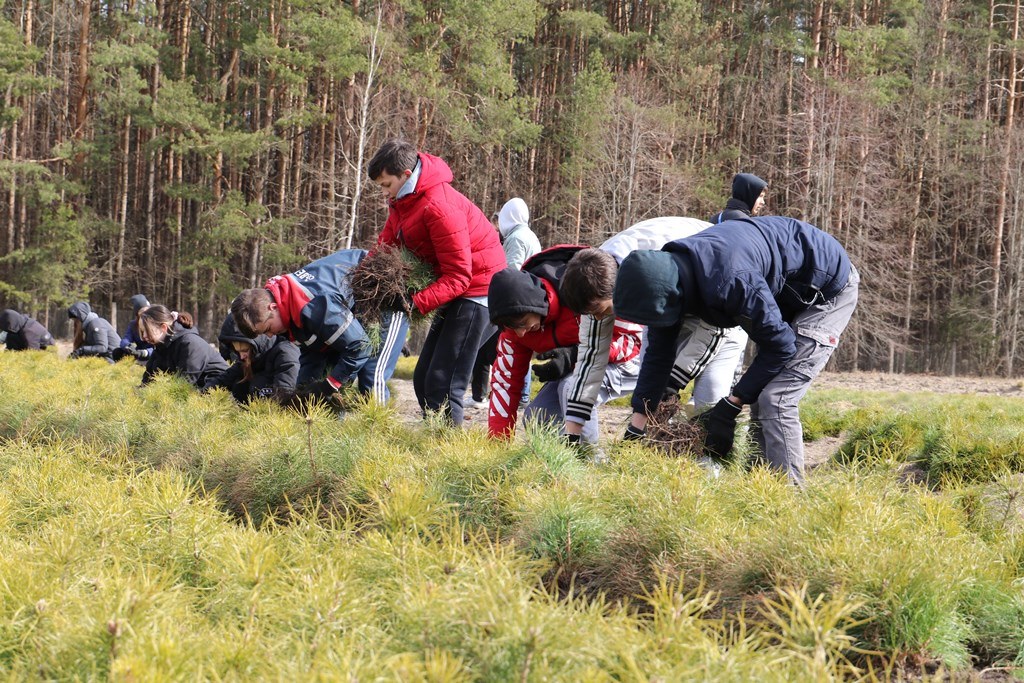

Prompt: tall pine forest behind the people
xmin=0 ymin=0 xmax=1024 ymax=376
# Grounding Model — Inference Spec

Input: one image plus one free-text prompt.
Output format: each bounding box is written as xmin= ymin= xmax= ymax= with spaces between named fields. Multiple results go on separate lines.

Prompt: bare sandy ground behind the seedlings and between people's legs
xmin=391 ymin=373 xmax=1024 ymax=468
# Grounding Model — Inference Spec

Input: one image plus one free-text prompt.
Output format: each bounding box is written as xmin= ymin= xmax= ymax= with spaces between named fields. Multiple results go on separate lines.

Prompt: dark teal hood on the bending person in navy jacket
xmin=611 ymin=249 xmax=683 ymax=328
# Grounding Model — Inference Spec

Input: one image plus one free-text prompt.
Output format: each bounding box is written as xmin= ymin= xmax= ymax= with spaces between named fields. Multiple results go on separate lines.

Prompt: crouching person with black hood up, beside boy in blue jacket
xmin=215 ymin=313 xmax=299 ymax=403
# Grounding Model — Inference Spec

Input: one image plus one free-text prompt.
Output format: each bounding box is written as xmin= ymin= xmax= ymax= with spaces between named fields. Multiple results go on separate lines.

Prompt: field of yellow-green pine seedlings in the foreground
xmin=0 ymin=353 xmax=1024 ymax=681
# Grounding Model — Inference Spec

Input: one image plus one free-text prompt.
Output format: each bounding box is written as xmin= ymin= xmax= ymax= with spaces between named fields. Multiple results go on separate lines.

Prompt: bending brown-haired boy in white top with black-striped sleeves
xmin=559 ymin=216 xmax=746 ymax=441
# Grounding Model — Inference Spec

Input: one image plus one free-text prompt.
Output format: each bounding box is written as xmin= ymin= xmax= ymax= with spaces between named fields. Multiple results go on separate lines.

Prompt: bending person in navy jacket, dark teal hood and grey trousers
xmin=612 ymin=216 xmax=860 ymax=484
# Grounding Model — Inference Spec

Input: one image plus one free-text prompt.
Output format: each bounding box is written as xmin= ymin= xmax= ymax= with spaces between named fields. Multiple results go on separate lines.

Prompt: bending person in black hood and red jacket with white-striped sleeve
xmin=487 ymin=246 xmax=641 ymax=444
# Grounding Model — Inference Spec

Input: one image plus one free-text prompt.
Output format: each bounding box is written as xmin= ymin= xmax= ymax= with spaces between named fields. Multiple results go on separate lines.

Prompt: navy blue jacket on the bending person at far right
xmin=615 ymin=216 xmax=852 ymax=410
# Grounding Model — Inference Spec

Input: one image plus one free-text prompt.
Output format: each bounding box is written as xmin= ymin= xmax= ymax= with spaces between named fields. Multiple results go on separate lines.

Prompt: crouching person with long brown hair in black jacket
xmin=138 ymin=304 xmax=227 ymax=389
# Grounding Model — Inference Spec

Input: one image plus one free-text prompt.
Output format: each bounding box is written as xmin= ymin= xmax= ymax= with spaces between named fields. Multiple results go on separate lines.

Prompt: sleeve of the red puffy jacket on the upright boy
xmin=413 ymin=204 xmax=473 ymax=313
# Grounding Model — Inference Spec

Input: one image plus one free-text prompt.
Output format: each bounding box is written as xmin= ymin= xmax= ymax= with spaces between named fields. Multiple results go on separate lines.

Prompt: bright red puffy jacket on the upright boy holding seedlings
xmin=377 ymin=152 xmax=506 ymax=313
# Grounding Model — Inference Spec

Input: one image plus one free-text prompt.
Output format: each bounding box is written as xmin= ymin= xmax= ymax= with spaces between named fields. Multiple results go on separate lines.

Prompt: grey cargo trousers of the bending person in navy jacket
xmin=751 ymin=268 xmax=860 ymax=484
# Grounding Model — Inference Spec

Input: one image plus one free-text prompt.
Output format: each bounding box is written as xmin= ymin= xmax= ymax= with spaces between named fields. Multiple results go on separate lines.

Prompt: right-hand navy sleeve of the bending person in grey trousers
xmin=727 ymin=278 xmax=797 ymax=403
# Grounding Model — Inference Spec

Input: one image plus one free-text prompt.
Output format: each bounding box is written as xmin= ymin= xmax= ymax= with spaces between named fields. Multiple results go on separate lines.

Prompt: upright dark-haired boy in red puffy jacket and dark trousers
xmin=368 ymin=140 xmax=506 ymax=425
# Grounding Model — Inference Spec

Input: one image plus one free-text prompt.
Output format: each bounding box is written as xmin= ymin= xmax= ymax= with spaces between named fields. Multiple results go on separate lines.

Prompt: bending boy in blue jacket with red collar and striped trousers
xmin=231 ymin=249 xmax=409 ymax=403
